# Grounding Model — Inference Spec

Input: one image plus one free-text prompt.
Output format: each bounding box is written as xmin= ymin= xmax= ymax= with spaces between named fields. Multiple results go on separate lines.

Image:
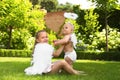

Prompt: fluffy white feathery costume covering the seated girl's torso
xmin=24 ymin=43 xmax=54 ymax=75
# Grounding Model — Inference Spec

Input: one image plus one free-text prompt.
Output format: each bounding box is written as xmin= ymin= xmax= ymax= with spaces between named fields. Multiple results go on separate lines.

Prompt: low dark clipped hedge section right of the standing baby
xmin=76 ymin=51 xmax=120 ymax=61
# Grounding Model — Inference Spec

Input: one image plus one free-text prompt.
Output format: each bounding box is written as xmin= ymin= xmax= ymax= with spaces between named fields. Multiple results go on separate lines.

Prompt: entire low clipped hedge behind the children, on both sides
xmin=0 ymin=49 xmax=120 ymax=61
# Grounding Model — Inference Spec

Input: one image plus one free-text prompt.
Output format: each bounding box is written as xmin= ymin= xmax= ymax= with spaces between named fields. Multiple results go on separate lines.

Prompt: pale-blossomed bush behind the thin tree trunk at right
xmin=89 ymin=28 xmax=120 ymax=51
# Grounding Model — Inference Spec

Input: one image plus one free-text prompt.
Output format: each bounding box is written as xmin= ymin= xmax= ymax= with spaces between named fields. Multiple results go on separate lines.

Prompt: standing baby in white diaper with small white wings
xmin=54 ymin=23 xmax=77 ymax=65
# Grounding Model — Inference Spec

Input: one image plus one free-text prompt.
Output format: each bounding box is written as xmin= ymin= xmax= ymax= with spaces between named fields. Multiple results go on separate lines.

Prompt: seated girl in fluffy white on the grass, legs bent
xmin=24 ymin=30 xmax=79 ymax=75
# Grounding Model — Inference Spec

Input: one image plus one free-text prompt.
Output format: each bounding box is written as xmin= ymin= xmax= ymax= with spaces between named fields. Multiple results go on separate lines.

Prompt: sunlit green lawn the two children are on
xmin=0 ymin=57 xmax=120 ymax=80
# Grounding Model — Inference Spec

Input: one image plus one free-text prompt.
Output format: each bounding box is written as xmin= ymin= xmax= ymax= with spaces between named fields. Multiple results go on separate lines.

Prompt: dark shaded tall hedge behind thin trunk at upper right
xmin=94 ymin=2 xmax=120 ymax=30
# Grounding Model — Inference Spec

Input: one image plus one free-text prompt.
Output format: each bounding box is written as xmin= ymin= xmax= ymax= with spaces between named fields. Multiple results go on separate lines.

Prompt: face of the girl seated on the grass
xmin=36 ymin=32 xmax=48 ymax=43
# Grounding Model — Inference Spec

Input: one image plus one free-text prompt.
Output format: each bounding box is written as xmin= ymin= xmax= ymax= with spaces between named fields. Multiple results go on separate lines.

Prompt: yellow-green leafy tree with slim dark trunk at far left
xmin=0 ymin=0 xmax=32 ymax=48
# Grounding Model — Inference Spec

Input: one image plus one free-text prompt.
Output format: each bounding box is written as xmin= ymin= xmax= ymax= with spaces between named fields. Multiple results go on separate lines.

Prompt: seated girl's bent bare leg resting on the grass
xmin=50 ymin=60 xmax=79 ymax=75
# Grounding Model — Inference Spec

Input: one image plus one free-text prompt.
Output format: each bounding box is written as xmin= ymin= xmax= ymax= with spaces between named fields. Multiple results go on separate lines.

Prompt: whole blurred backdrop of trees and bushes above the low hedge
xmin=0 ymin=0 xmax=120 ymax=51
